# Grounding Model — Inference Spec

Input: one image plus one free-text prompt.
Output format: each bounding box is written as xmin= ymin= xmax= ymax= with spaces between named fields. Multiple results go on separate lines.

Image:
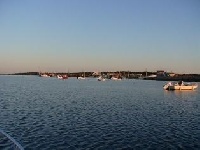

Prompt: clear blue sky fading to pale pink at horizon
xmin=0 ymin=0 xmax=200 ymax=74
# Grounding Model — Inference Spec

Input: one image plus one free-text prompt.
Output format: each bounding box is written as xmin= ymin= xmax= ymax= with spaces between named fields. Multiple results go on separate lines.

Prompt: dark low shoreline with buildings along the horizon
xmin=0 ymin=71 xmax=200 ymax=82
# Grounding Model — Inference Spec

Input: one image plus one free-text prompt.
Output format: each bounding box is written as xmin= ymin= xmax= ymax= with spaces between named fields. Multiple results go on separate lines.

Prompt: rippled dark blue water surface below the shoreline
xmin=0 ymin=76 xmax=200 ymax=150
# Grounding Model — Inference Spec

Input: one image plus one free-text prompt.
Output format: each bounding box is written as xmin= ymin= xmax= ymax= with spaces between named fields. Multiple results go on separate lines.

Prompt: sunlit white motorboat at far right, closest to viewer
xmin=163 ymin=81 xmax=198 ymax=90
